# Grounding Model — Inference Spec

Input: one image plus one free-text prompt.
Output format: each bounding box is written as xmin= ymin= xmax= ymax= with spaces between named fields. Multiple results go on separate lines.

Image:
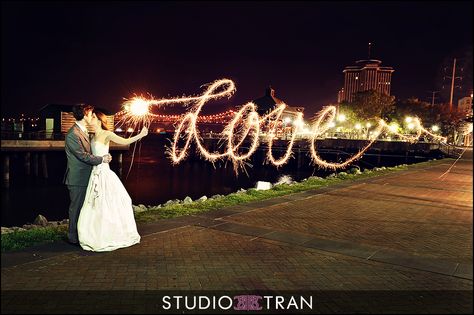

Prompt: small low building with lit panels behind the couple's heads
xmin=38 ymin=104 xmax=114 ymax=139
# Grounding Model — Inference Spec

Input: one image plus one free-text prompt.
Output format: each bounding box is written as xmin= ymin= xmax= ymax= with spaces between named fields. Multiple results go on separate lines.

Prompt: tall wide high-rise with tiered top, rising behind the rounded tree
xmin=337 ymin=59 xmax=395 ymax=103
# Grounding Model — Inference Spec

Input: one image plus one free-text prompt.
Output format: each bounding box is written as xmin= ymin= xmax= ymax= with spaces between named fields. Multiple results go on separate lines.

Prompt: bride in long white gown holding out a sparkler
xmin=77 ymin=111 xmax=148 ymax=252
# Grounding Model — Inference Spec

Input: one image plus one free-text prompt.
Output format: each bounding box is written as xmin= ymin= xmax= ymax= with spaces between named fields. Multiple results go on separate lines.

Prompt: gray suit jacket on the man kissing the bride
xmin=64 ymin=124 xmax=102 ymax=186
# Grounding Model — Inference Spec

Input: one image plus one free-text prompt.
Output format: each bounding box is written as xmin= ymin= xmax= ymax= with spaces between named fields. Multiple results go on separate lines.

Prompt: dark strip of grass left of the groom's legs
xmin=1 ymin=226 xmax=67 ymax=252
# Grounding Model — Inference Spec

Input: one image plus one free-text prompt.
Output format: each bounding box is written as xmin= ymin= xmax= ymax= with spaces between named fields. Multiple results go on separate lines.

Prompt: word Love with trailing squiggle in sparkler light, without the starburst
xmin=168 ymin=79 xmax=446 ymax=172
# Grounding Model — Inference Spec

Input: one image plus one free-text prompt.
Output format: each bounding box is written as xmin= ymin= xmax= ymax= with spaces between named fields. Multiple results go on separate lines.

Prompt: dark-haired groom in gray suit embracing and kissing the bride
xmin=64 ymin=104 xmax=112 ymax=245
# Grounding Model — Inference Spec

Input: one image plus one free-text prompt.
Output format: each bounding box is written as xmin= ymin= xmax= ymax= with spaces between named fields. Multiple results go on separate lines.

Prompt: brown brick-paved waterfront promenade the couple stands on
xmin=1 ymin=151 xmax=473 ymax=313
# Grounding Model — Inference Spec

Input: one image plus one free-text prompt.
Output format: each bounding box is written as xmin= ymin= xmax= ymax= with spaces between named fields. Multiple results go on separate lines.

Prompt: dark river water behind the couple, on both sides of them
xmin=1 ymin=134 xmax=434 ymax=226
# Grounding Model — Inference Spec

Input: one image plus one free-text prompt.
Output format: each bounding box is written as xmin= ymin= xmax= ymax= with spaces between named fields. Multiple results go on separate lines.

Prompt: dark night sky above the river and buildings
xmin=1 ymin=1 xmax=473 ymax=117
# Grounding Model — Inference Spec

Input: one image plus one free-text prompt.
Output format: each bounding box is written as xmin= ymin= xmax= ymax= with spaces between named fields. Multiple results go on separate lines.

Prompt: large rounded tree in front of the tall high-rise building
xmin=350 ymin=90 xmax=395 ymax=119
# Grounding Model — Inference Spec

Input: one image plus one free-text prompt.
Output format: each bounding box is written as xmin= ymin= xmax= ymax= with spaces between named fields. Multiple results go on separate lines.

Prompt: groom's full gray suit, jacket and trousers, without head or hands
xmin=64 ymin=124 xmax=102 ymax=243
